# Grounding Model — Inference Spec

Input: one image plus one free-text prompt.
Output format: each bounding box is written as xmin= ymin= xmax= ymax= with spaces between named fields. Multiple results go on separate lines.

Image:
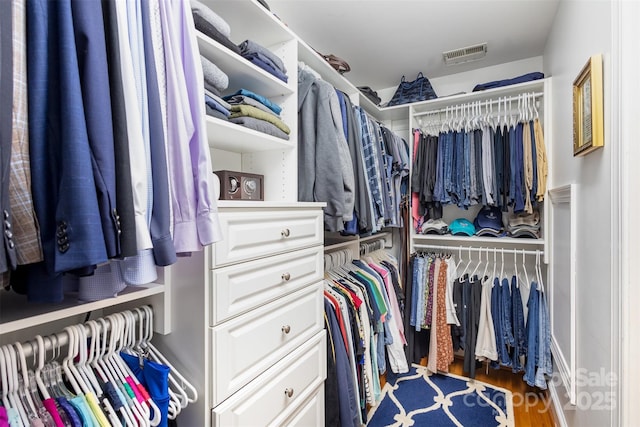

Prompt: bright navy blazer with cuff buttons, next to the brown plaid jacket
xmin=26 ymin=0 xmax=107 ymax=302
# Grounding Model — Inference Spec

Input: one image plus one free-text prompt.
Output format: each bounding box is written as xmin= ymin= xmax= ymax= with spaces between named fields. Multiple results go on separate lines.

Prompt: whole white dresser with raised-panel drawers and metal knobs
xmin=157 ymin=202 xmax=326 ymax=427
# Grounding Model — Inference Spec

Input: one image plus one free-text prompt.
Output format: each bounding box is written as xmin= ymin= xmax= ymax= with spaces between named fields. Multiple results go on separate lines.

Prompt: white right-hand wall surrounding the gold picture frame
xmin=544 ymin=0 xmax=618 ymax=427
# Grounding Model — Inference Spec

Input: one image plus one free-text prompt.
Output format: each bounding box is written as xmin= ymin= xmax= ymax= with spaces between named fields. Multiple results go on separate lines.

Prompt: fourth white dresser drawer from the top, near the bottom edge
xmin=212 ymin=331 xmax=327 ymax=427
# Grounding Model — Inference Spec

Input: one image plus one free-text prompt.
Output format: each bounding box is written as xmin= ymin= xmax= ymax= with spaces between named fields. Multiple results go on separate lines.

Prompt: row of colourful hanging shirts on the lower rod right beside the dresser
xmin=325 ymin=251 xmax=409 ymax=425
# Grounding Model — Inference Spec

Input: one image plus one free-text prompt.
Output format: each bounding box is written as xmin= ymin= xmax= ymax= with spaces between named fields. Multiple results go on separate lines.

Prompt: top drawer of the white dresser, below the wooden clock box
xmin=211 ymin=208 xmax=324 ymax=268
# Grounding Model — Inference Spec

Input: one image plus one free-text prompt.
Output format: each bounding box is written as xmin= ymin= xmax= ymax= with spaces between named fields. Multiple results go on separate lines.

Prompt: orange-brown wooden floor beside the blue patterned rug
xmin=381 ymin=357 xmax=556 ymax=427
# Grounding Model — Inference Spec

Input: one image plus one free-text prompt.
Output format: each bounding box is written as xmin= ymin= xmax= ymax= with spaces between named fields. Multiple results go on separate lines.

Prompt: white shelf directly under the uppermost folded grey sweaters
xmin=197 ymin=32 xmax=294 ymax=98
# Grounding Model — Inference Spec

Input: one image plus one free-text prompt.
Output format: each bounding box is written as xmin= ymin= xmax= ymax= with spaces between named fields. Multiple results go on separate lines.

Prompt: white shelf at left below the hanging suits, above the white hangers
xmin=0 ymin=283 xmax=165 ymax=336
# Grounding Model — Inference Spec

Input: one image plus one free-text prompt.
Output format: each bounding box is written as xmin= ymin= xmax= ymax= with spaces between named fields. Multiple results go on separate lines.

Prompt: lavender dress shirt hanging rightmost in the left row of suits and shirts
xmin=160 ymin=0 xmax=222 ymax=253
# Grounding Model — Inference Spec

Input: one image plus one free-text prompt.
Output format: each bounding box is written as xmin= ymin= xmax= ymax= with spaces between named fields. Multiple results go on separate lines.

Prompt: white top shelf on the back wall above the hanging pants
xmin=410 ymin=78 xmax=548 ymax=115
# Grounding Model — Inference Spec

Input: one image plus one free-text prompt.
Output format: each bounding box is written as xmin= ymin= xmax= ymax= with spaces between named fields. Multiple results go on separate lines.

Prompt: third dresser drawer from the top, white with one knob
xmin=210 ymin=282 xmax=324 ymax=406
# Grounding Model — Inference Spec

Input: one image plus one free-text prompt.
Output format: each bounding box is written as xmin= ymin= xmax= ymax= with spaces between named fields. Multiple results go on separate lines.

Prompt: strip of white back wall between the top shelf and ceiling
xmin=377 ymin=56 xmax=542 ymax=105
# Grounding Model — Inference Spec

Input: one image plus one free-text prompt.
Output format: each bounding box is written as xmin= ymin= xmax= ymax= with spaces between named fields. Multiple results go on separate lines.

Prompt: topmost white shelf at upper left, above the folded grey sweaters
xmin=201 ymin=0 xmax=296 ymax=50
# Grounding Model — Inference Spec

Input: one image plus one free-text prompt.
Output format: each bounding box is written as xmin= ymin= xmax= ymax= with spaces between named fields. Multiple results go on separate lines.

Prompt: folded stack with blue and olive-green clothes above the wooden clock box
xmin=223 ymin=89 xmax=291 ymax=140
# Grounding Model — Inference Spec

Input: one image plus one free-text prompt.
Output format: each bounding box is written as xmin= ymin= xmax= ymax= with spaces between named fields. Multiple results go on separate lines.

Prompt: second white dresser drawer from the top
xmin=209 ymin=246 xmax=324 ymax=326
